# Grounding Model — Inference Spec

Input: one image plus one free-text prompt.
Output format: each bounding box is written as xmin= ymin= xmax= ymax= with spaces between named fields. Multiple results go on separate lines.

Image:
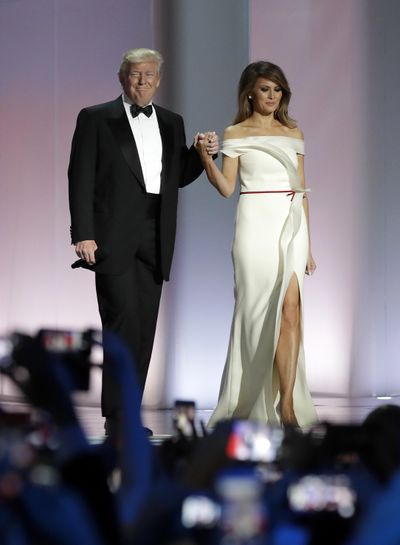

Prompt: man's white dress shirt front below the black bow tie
xmin=122 ymin=93 xmax=162 ymax=193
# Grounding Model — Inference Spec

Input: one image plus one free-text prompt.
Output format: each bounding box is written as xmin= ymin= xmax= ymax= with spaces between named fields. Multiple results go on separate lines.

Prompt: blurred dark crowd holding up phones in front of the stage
xmin=0 ymin=331 xmax=400 ymax=545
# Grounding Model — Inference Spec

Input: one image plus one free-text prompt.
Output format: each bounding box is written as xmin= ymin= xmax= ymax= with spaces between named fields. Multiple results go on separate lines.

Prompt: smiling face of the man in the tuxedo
xmin=121 ymin=62 xmax=160 ymax=106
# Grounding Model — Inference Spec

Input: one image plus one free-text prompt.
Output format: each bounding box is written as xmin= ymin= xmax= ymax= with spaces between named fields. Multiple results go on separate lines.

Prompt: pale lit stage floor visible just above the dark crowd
xmin=1 ymin=397 xmax=400 ymax=442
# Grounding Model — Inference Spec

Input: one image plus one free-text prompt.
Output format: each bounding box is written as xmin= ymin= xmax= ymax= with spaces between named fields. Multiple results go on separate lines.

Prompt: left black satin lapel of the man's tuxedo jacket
xmin=107 ymin=97 xmax=145 ymax=189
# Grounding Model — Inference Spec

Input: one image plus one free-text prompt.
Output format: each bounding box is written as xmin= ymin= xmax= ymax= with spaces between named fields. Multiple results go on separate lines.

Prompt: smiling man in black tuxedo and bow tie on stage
xmin=68 ymin=49 xmax=218 ymax=429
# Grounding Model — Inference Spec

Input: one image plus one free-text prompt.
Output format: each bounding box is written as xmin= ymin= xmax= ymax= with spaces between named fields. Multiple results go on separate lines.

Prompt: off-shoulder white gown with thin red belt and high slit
xmin=209 ymin=136 xmax=317 ymax=427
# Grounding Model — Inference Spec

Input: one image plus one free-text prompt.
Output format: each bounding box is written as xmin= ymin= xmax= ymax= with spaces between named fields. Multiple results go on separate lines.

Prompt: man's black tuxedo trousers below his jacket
xmin=96 ymin=194 xmax=163 ymax=417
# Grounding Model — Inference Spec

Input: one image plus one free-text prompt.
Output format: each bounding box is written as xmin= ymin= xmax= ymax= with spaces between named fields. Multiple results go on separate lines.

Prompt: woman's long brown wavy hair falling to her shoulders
xmin=234 ymin=61 xmax=296 ymax=129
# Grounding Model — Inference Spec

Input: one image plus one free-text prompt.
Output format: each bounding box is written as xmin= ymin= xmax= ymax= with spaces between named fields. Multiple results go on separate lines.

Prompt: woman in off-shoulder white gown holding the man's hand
xmin=197 ymin=61 xmax=317 ymax=427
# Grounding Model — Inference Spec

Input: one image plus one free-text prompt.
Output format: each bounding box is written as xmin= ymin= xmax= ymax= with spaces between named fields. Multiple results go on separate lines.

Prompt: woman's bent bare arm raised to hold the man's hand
xmin=195 ymin=131 xmax=239 ymax=197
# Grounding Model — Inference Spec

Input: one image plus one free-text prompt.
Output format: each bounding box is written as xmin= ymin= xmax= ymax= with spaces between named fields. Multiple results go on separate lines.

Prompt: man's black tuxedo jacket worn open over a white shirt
xmin=68 ymin=97 xmax=203 ymax=280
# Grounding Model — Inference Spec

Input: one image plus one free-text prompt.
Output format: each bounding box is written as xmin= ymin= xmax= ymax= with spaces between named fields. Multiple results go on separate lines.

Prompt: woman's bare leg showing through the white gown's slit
xmin=275 ymin=274 xmax=300 ymax=426
